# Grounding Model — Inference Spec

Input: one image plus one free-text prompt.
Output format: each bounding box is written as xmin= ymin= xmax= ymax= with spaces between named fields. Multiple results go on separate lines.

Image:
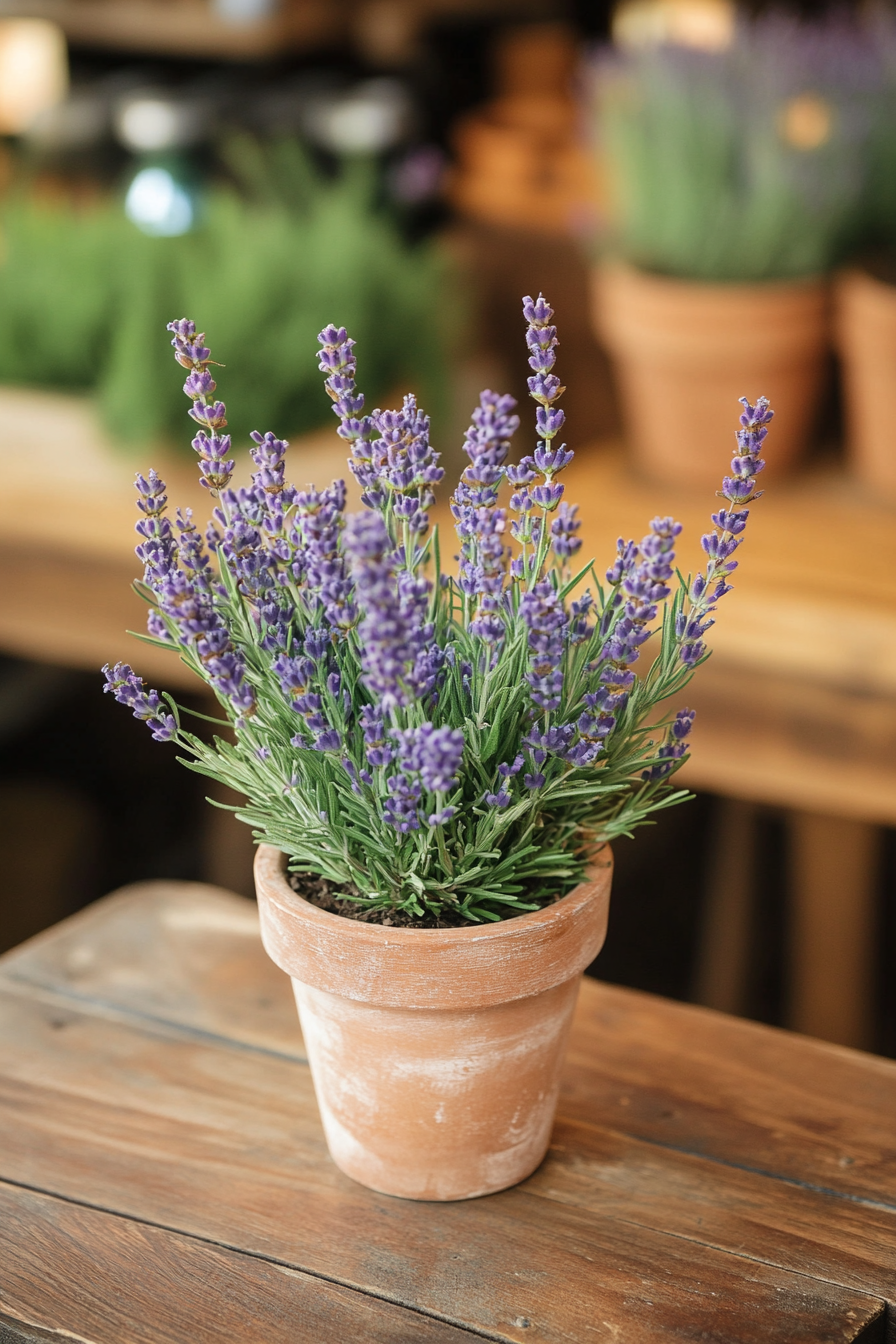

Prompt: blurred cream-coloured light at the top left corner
xmin=0 ymin=19 xmax=69 ymax=136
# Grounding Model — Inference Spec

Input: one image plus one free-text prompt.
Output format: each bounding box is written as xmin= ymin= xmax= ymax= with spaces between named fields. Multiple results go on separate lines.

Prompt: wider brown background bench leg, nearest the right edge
xmin=789 ymin=812 xmax=881 ymax=1050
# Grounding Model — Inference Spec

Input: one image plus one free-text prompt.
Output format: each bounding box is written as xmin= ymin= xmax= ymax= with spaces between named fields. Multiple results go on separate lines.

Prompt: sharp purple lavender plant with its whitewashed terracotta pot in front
xmin=105 ymin=296 xmax=771 ymax=1199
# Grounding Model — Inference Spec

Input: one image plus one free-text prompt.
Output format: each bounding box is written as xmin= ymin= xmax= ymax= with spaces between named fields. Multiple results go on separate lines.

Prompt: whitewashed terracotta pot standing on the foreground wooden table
xmin=255 ymin=845 xmax=613 ymax=1199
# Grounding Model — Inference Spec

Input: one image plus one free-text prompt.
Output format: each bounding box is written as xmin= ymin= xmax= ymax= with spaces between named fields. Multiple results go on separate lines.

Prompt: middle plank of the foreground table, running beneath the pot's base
xmin=0 ymin=986 xmax=883 ymax=1344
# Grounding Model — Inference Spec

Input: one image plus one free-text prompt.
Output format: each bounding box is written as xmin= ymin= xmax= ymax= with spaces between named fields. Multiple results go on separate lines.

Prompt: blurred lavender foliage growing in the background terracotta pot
xmin=594 ymin=16 xmax=883 ymax=281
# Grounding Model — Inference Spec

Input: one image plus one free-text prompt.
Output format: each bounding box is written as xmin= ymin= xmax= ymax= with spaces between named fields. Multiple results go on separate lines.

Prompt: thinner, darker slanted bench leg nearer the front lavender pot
xmin=693 ymin=798 xmax=758 ymax=1013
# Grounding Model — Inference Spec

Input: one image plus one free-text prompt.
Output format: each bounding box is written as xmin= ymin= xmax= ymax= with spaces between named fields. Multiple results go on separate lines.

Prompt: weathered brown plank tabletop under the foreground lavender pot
xmin=0 ymin=883 xmax=896 ymax=1344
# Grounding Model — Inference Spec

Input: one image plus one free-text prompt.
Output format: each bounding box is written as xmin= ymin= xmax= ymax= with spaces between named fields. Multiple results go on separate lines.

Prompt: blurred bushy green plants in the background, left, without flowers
xmin=0 ymin=137 xmax=457 ymax=445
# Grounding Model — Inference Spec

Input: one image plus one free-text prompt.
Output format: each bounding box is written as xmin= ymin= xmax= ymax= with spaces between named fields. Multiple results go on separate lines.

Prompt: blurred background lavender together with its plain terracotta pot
xmin=592 ymin=15 xmax=881 ymax=487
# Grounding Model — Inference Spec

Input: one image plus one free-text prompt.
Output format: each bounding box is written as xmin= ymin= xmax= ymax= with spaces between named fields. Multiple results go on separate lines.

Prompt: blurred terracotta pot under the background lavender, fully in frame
xmin=592 ymin=265 xmax=829 ymax=488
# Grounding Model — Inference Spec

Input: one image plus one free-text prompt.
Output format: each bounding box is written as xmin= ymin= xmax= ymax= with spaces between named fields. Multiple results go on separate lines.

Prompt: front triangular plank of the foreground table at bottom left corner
xmin=0 ymin=1183 xmax=476 ymax=1344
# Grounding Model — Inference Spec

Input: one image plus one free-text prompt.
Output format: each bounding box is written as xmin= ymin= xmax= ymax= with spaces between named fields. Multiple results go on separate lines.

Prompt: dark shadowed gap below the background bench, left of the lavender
xmin=0 ymin=659 xmax=208 ymax=949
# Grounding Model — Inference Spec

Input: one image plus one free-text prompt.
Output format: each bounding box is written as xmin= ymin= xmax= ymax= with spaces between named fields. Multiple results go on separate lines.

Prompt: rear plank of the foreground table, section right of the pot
xmin=560 ymin=981 xmax=896 ymax=1208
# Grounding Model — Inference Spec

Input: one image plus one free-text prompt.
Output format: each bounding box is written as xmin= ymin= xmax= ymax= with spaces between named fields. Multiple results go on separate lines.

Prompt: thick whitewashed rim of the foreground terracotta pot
xmin=255 ymin=844 xmax=613 ymax=1008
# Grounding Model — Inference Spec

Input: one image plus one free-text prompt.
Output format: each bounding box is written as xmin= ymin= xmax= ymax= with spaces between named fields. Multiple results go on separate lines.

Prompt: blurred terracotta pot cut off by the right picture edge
xmin=834 ymin=270 xmax=896 ymax=497
